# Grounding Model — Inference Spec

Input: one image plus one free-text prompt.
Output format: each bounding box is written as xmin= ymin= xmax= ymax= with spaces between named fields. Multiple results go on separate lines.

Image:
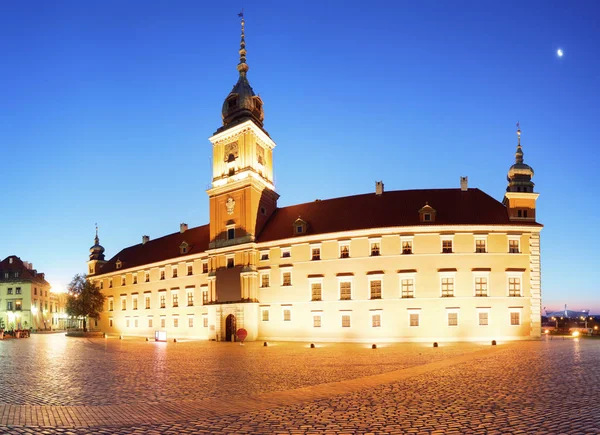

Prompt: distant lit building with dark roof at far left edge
xmin=0 ymin=255 xmax=64 ymax=330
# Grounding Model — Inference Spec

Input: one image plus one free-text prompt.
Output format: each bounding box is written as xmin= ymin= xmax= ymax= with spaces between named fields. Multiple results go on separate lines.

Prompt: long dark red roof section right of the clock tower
xmin=258 ymin=189 xmax=539 ymax=242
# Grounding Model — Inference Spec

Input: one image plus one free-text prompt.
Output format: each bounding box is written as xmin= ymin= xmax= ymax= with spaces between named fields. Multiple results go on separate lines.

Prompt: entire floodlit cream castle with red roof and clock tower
xmin=88 ymin=19 xmax=542 ymax=342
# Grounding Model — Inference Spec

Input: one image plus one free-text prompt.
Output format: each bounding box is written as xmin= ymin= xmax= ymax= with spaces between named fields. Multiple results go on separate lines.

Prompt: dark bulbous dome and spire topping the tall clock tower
xmin=219 ymin=17 xmax=265 ymax=130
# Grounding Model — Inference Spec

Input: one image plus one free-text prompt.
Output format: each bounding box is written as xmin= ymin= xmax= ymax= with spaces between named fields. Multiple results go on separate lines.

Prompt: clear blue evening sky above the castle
xmin=0 ymin=0 xmax=600 ymax=313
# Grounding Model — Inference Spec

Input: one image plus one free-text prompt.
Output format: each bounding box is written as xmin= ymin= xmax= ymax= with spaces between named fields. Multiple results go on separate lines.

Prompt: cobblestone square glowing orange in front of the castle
xmin=0 ymin=336 xmax=600 ymax=435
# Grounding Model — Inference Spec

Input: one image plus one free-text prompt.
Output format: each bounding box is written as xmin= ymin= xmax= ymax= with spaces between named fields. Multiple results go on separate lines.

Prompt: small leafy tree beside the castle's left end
xmin=66 ymin=274 xmax=106 ymax=332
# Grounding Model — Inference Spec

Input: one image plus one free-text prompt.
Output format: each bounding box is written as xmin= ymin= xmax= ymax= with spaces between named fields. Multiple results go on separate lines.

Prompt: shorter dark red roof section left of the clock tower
xmin=96 ymin=225 xmax=210 ymax=275
